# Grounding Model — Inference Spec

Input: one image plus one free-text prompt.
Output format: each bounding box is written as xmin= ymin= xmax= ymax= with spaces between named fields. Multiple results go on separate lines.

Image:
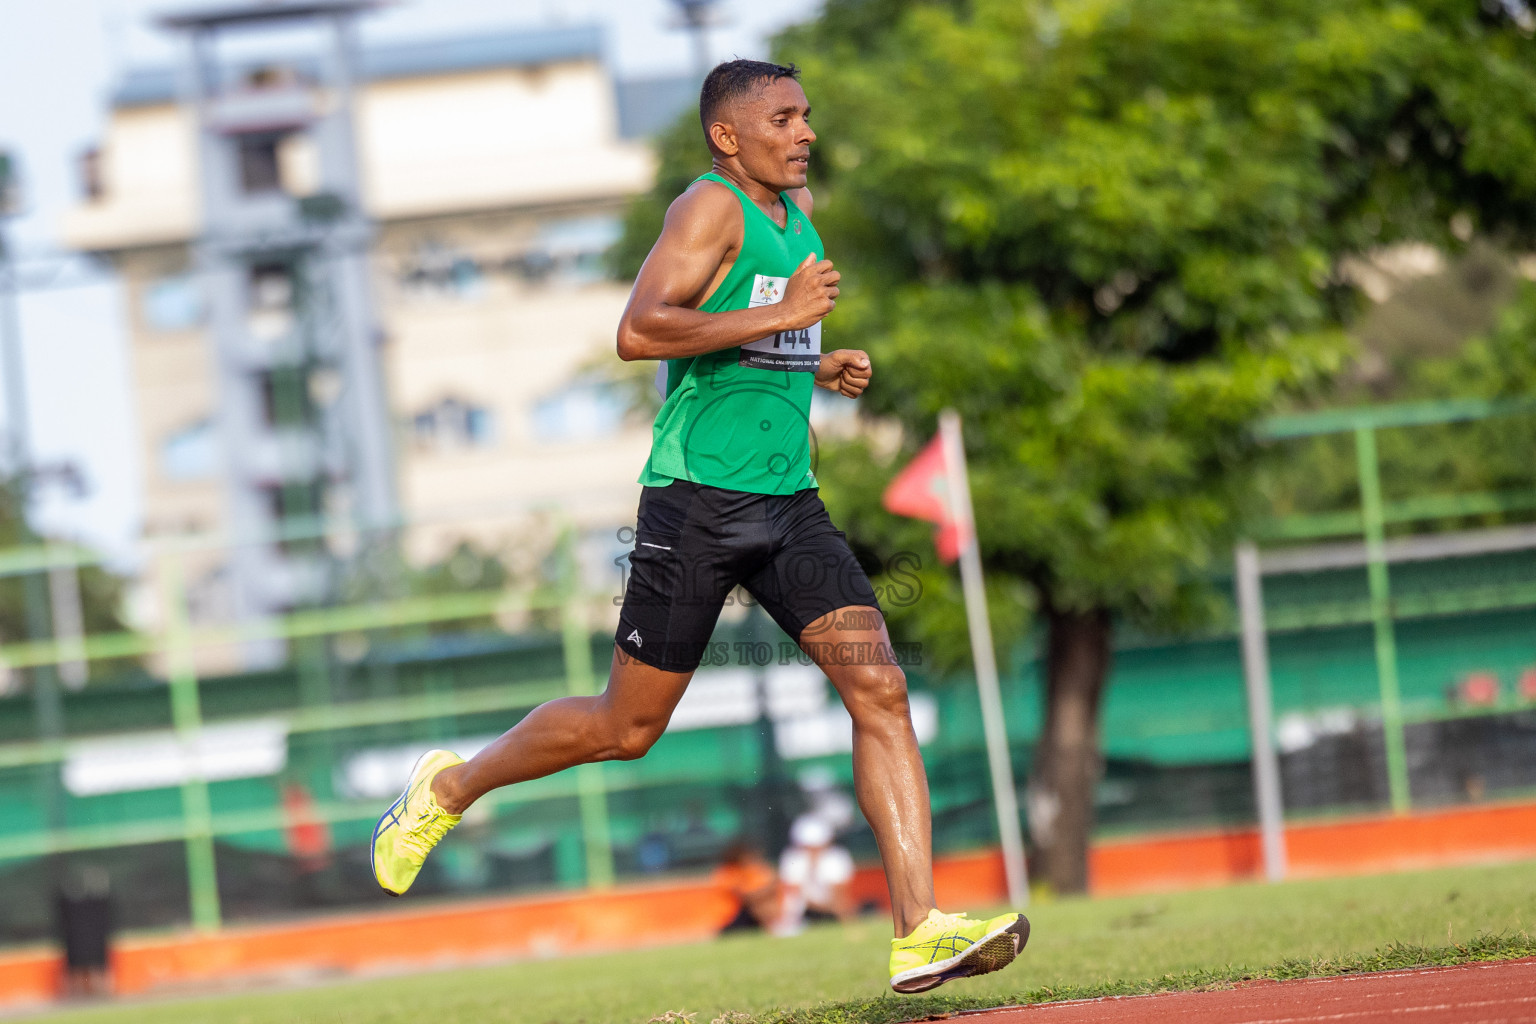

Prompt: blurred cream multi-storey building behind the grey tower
xmin=65 ymin=28 xmax=693 ymax=666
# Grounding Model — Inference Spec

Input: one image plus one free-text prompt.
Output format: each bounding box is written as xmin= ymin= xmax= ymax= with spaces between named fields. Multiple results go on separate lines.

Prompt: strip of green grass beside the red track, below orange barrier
xmin=48 ymin=861 xmax=1536 ymax=1024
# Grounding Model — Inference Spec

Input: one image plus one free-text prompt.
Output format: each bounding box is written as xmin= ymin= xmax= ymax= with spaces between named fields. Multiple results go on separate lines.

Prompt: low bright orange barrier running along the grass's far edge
xmin=0 ymin=804 xmax=1536 ymax=1007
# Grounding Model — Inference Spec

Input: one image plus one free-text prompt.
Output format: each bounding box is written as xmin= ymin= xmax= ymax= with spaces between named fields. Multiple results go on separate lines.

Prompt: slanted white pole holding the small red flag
xmin=938 ymin=408 xmax=1029 ymax=907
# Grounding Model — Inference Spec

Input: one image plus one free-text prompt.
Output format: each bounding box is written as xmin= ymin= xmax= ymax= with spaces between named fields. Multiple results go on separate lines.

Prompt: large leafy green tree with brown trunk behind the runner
xmin=625 ymin=0 xmax=1536 ymax=892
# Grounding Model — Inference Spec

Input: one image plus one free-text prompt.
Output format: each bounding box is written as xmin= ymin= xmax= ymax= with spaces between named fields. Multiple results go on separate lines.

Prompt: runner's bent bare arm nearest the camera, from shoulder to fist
xmin=619 ymin=181 xmax=840 ymax=361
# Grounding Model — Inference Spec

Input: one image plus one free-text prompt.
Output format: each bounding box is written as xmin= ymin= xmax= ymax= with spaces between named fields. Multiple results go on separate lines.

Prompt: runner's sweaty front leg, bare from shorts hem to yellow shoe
xmin=800 ymin=605 xmax=934 ymax=938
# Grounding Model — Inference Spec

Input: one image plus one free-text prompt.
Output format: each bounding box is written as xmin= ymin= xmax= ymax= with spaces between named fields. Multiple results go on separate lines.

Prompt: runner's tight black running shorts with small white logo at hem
xmin=614 ymin=481 xmax=880 ymax=672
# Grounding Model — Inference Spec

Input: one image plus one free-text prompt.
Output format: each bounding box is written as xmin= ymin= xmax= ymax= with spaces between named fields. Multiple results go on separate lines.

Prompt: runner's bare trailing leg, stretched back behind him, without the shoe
xmin=432 ymin=649 xmax=693 ymax=814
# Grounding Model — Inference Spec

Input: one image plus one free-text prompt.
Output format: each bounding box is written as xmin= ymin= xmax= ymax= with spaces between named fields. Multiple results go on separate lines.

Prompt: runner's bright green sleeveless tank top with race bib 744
xmin=641 ymin=173 xmax=822 ymax=494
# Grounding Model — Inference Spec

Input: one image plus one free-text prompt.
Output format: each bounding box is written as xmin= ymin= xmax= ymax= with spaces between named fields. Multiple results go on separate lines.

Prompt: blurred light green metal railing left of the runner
xmin=0 ymin=524 xmax=617 ymax=929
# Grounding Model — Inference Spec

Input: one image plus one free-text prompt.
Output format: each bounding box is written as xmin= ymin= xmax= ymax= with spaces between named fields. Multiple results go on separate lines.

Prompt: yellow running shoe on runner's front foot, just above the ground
xmin=891 ymin=910 xmax=1029 ymax=993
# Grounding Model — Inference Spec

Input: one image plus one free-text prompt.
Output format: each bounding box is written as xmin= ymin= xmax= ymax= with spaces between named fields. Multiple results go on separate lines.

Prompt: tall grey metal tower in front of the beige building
xmin=160 ymin=0 xmax=398 ymax=662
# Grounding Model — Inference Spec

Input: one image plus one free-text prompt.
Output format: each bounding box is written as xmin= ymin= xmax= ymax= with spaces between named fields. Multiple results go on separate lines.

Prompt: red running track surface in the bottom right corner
xmin=965 ymin=958 xmax=1536 ymax=1024
